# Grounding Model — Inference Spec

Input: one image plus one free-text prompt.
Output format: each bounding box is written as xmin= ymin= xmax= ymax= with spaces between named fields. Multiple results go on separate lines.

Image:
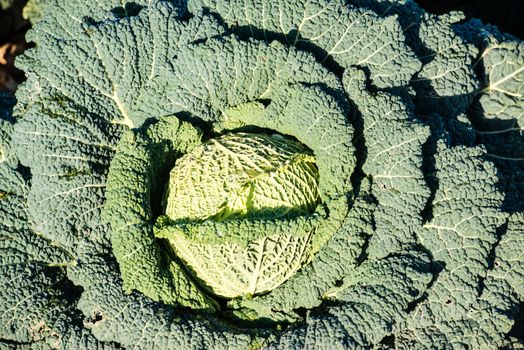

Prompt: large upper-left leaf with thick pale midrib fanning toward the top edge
xmin=15 ymin=1 xmax=222 ymax=127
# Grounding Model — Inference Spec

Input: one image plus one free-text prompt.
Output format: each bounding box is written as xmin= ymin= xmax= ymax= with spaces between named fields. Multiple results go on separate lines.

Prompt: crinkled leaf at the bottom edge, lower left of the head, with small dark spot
xmin=68 ymin=241 xmax=257 ymax=350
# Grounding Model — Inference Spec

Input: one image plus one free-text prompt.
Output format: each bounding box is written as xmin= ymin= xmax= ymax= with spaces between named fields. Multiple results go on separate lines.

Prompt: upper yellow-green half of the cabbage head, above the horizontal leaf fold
xmin=166 ymin=133 xmax=319 ymax=221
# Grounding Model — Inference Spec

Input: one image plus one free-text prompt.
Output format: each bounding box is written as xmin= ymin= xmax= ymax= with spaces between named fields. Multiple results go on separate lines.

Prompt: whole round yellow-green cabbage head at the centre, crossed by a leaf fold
xmin=159 ymin=133 xmax=319 ymax=298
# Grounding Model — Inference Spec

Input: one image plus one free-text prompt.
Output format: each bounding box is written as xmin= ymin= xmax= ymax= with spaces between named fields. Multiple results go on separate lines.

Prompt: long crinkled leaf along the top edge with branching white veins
xmin=188 ymin=0 xmax=420 ymax=87
